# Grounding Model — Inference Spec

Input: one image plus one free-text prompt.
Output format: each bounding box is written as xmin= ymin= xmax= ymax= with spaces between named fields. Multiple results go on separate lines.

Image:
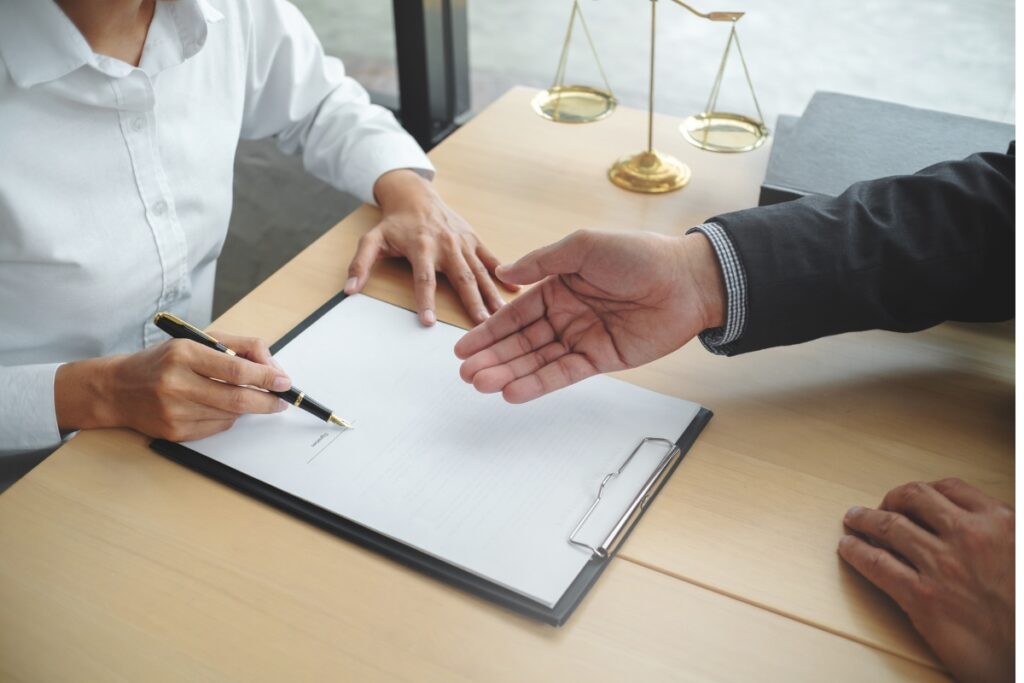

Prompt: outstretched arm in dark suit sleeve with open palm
xmin=456 ymin=154 xmax=1014 ymax=402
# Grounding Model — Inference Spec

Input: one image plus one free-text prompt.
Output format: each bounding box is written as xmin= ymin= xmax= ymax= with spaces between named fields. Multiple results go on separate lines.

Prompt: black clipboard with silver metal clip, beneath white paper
xmin=151 ymin=293 xmax=712 ymax=627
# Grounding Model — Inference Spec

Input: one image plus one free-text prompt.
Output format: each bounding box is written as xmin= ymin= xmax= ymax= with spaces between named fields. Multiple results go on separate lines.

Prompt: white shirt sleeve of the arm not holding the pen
xmin=241 ymin=0 xmax=434 ymax=204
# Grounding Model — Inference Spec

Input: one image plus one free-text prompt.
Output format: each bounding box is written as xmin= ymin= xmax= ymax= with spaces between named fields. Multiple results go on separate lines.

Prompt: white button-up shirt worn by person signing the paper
xmin=0 ymin=0 xmax=432 ymax=462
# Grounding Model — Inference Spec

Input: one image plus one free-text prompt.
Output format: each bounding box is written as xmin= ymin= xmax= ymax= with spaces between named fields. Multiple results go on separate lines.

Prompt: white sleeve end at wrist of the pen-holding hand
xmin=0 ymin=362 xmax=60 ymax=458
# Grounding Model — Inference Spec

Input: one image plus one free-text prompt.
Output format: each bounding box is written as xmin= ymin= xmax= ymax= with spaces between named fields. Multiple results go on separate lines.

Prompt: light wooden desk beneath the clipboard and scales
xmin=0 ymin=89 xmax=1014 ymax=681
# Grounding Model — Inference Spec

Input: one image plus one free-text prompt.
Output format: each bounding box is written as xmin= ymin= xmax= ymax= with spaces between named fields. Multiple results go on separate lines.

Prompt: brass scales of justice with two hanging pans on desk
xmin=532 ymin=0 xmax=769 ymax=194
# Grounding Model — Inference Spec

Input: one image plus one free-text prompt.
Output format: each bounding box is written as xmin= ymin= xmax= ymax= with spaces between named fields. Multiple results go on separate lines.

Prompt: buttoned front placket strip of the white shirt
xmin=115 ymin=69 xmax=191 ymax=346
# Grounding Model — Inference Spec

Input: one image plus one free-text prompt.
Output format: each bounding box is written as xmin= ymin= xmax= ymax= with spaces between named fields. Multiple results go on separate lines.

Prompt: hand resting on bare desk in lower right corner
xmin=839 ymin=479 xmax=1015 ymax=682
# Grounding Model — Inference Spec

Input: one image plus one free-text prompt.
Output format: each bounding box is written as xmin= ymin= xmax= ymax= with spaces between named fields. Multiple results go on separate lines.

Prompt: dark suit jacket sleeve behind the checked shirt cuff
xmin=709 ymin=154 xmax=1014 ymax=355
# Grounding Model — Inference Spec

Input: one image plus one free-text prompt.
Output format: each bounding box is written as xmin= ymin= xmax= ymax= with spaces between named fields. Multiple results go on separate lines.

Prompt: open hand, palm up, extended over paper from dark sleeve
xmin=456 ymin=230 xmax=725 ymax=403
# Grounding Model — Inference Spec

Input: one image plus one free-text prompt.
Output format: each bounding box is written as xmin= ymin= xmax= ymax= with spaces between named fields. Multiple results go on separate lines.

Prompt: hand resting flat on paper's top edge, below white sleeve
xmin=345 ymin=169 xmax=518 ymax=325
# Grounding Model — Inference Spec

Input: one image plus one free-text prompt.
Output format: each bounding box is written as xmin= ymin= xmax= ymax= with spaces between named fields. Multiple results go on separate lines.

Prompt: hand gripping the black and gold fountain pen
xmin=54 ymin=334 xmax=292 ymax=441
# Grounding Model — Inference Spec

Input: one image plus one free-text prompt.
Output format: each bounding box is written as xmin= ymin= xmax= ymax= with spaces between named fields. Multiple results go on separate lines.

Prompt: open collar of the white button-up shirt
xmin=0 ymin=0 xmax=224 ymax=88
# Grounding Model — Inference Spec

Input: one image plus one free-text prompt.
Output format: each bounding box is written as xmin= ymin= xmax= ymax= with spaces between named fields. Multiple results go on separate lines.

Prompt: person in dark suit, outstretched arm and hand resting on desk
xmin=455 ymin=155 xmax=1015 ymax=681
